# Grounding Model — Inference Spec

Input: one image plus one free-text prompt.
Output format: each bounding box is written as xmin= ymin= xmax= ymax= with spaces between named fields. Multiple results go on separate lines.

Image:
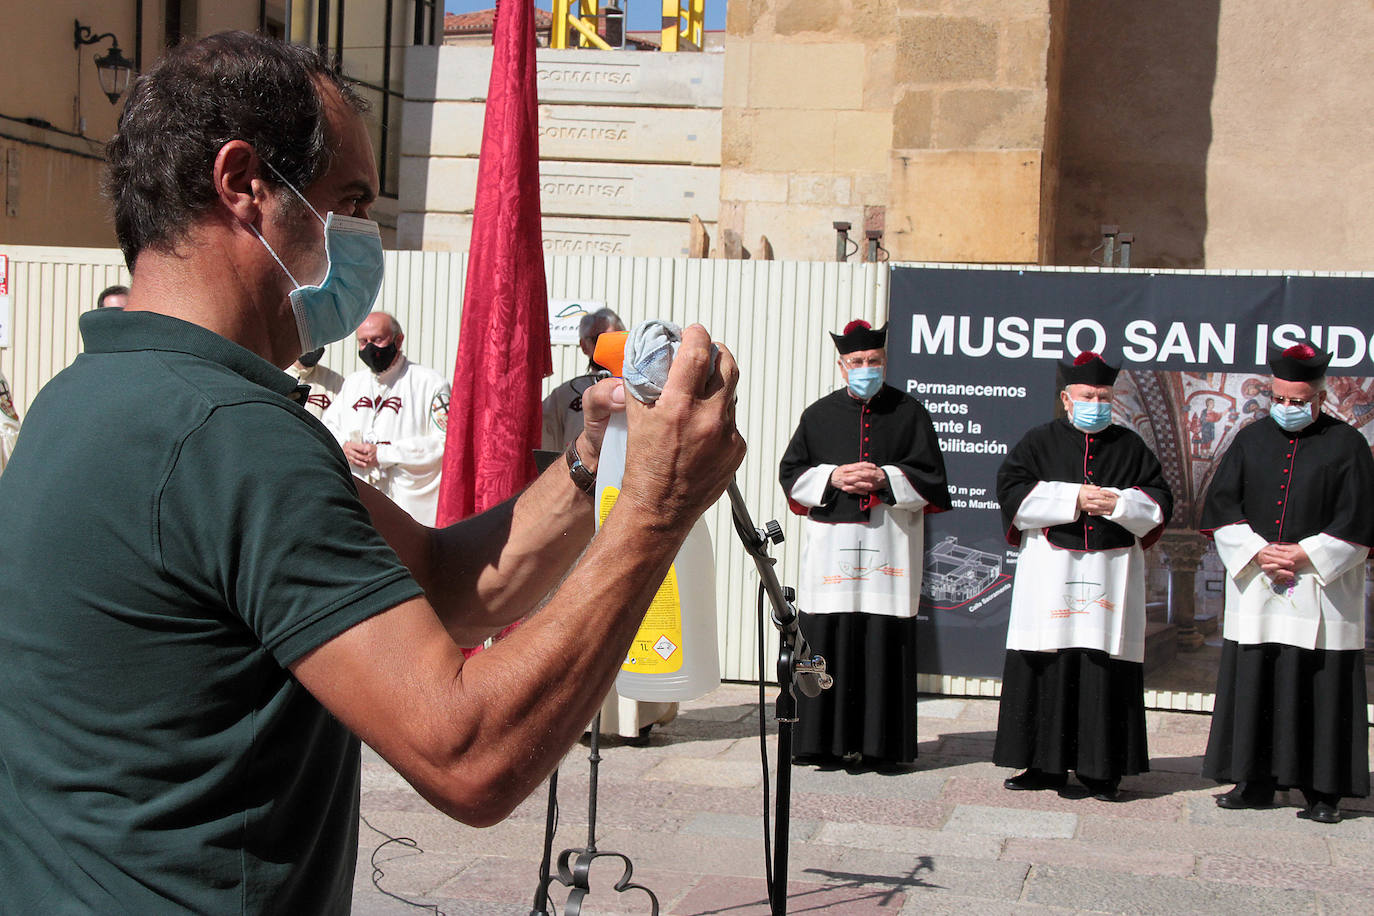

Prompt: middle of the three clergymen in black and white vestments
xmin=992 ymin=352 xmax=1173 ymax=801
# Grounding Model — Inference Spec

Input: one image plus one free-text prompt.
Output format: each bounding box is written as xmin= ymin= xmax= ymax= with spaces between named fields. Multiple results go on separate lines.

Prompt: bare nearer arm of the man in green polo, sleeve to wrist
xmin=299 ymin=494 xmax=703 ymax=827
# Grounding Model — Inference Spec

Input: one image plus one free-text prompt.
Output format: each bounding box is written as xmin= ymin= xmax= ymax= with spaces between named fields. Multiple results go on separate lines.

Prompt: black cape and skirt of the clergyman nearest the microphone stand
xmin=779 ymin=385 xmax=949 ymax=764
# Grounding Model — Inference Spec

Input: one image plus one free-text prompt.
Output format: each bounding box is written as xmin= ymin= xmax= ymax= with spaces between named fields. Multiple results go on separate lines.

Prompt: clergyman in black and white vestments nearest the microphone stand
xmin=779 ymin=321 xmax=949 ymax=766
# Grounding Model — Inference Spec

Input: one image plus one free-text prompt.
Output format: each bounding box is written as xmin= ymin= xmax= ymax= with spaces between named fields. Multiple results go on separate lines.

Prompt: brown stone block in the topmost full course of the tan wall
xmin=897 ymin=16 xmax=998 ymax=84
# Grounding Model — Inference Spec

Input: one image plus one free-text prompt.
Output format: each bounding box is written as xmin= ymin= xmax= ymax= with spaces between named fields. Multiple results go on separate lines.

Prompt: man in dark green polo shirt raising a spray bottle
xmin=0 ymin=33 xmax=743 ymax=913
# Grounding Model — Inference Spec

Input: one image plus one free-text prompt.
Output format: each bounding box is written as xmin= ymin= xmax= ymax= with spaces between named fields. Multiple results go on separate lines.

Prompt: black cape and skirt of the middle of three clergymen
xmin=992 ymin=419 xmax=1173 ymax=780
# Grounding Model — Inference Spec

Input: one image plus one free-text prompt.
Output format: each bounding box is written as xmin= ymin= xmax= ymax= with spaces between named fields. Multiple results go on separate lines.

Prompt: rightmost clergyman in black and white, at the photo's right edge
xmin=1202 ymin=345 xmax=1374 ymax=823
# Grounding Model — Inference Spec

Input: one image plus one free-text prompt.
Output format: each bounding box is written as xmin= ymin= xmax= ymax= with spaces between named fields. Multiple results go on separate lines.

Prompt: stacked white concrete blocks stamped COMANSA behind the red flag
xmin=397 ymin=45 xmax=723 ymax=257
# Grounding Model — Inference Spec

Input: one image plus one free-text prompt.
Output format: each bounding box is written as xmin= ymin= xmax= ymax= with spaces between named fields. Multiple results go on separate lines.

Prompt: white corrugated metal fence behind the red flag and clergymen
xmin=0 ymin=246 xmax=901 ymax=695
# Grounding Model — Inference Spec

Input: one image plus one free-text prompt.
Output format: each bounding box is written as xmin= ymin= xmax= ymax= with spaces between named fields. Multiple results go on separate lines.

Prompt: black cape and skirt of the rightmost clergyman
xmin=1201 ymin=413 xmax=1374 ymax=797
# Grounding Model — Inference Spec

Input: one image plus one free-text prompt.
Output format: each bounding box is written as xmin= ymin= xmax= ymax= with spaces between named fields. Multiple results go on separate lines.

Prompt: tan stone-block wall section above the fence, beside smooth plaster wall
xmin=720 ymin=0 xmax=1050 ymax=262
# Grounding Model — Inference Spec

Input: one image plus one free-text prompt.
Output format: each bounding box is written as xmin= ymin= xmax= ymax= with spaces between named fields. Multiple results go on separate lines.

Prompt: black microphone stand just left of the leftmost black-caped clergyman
xmin=727 ymin=481 xmax=834 ymax=916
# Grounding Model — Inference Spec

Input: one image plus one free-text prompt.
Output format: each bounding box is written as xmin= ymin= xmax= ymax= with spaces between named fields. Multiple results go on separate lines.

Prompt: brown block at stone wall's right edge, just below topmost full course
xmin=932 ymin=89 xmax=1044 ymax=150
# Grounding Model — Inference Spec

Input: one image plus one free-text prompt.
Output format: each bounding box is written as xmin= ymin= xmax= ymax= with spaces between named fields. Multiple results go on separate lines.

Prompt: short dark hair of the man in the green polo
xmin=106 ymin=32 xmax=367 ymax=271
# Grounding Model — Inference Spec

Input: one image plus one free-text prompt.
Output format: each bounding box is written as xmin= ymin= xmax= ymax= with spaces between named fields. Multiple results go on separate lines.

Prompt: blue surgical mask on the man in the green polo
xmin=249 ymin=163 xmax=383 ymax=353
